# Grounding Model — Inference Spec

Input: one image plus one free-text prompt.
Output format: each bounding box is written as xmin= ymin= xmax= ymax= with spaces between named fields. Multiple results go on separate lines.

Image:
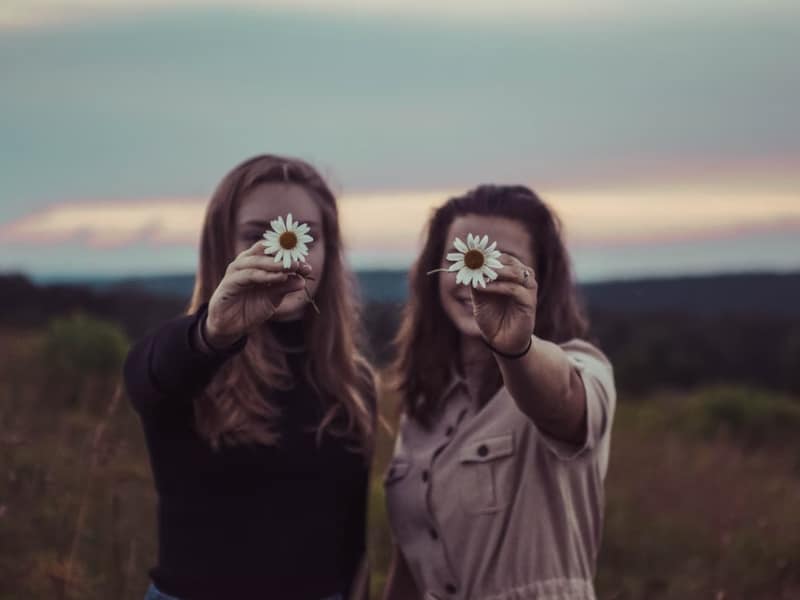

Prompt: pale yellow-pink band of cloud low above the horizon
xmin=0 ymin=186 xmax=800 ymax=251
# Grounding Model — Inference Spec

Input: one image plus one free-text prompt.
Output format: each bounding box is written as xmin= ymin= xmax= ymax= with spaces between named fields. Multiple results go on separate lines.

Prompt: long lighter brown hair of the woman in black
xmin=187 ymin=155 xmax=375 ymax=454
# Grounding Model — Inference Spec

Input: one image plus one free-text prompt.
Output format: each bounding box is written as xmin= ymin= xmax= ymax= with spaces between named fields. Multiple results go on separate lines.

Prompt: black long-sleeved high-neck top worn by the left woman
xmin=124 ymin=303 xmax=374 ymax=600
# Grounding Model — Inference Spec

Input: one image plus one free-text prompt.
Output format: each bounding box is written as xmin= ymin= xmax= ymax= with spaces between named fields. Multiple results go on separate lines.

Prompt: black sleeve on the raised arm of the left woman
xmin=123 ymin=302 xmax=247 ymax=414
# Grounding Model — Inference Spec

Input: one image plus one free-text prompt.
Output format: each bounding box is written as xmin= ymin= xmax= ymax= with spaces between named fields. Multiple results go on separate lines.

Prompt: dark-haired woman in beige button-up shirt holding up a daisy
xmin=384 ymin=185 xmax=616 ymax=600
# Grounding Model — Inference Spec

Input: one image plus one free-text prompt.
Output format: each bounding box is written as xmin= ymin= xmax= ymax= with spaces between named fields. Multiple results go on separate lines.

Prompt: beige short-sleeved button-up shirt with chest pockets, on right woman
xmin=384 ymin=339 xmax=616 ymax=600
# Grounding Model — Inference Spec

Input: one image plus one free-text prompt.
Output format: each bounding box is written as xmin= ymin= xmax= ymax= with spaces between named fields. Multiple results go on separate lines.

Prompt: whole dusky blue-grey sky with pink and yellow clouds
xmin=0 ymin=0 xmax=800 ymax=280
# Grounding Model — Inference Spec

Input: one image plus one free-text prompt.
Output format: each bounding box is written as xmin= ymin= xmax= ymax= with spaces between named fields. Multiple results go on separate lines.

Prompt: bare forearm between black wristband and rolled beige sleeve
xmin=495 ymin=336 xmax=586 ymax=444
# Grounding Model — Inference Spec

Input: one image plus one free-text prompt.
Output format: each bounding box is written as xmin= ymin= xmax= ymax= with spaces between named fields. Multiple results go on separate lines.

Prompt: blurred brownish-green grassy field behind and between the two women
xmin=0 ymin=317 xmax=800 ymax=600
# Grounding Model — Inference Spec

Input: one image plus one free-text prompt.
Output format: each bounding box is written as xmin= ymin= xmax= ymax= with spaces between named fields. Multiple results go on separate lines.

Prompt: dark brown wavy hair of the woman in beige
xmin=391 ymin=185 xmax=589 ymax=424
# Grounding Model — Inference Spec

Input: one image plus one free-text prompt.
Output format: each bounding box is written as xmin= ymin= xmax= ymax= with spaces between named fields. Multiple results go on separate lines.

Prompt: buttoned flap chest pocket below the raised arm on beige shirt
xmin=458 ymin=433 xmax=515 ymax=514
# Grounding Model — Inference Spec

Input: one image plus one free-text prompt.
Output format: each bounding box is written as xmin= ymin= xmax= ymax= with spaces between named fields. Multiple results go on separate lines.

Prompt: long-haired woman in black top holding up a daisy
xmin=124 ymin=155 xmax=376 ymax=600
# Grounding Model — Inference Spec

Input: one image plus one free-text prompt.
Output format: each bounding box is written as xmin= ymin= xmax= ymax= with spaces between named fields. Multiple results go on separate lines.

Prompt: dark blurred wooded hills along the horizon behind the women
xmin=0 ymin=272 xmax=800 ymax=393
